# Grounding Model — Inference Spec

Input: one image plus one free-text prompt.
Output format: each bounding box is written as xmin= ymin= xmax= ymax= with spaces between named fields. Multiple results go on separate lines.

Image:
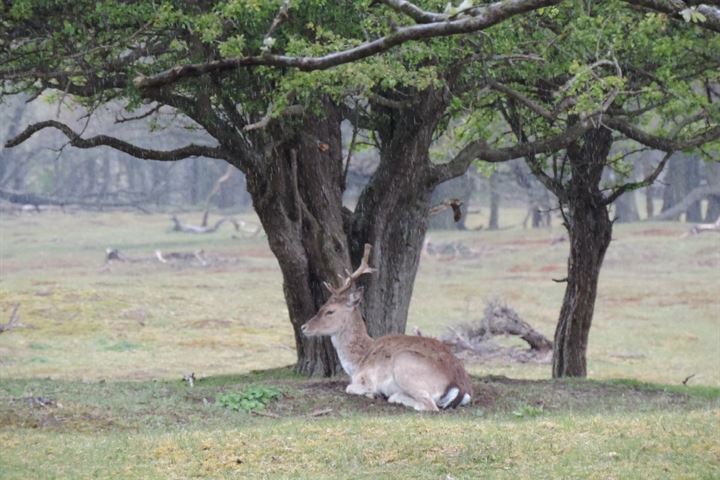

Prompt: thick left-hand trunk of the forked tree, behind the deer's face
xmin=247 ymin=104 xmax=350 ymax=376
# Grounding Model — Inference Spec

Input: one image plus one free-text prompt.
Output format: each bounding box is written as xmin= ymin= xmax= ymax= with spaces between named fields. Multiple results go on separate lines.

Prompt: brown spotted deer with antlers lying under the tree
xmin=301 ymin=244 xmax=472 ymax=412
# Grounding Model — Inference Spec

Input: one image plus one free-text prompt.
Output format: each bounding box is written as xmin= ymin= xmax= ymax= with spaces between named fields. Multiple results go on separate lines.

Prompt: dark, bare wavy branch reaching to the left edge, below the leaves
xmin=5 ymin=120 xmax=228 ymax=161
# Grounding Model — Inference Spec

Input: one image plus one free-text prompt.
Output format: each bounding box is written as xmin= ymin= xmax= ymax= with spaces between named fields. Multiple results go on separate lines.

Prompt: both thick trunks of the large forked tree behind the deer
xmin=247 ymin=91 xmax=450 ymax=376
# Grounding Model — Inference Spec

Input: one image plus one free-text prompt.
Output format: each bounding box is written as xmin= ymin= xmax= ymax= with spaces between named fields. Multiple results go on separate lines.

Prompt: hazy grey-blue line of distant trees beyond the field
xmin=0 ymin=95 xmax=720 ymax=225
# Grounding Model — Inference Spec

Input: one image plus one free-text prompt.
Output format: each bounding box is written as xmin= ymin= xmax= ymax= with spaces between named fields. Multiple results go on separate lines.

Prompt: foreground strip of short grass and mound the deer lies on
xmin=0 ymin=369 xmax=720 ymax=479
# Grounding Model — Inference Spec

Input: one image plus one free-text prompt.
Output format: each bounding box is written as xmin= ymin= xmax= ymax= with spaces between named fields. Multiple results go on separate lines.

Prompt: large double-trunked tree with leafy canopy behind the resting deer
xmin=0 ymin=0 xmax=558 ymax=375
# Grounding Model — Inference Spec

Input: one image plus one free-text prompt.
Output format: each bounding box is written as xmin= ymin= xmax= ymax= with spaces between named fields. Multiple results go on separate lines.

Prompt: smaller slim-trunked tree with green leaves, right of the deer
xmin=458 ymin=1 xmax=720 ymax=377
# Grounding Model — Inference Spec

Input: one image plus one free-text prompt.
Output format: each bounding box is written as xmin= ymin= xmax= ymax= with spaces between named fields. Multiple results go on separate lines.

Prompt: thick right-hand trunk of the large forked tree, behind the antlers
xmin=350 ymin=90 xmax=447 ymax=337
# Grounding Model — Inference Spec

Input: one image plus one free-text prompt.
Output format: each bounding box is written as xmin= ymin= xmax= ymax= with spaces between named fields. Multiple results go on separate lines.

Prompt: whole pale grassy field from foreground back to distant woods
xmin=0 ymin=212 xmax=720 ymax=479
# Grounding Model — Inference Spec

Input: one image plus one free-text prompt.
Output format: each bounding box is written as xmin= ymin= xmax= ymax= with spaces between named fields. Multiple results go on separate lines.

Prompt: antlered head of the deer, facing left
xmin=302 ymin=243 xmax=375 ymax=337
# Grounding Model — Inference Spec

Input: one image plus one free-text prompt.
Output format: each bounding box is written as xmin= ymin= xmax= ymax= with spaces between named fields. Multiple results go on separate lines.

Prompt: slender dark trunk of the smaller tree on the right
xmin=553 ymin=128 xmax=612 ymax=378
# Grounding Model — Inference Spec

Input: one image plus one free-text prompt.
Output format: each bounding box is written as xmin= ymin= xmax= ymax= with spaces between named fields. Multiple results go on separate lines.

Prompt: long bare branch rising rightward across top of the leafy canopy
xmin=134 ymin=0 xmax=560 ymax=89
